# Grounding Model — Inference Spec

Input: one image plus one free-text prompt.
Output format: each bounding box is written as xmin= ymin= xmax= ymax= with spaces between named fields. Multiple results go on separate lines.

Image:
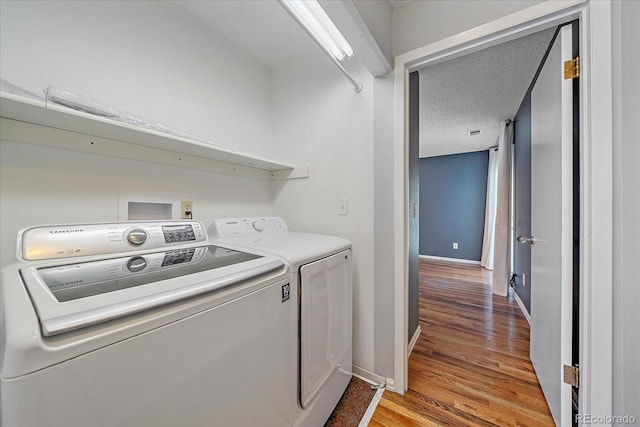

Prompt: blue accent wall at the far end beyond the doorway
xmin=420 ymin=151 xmax=489 ymax=261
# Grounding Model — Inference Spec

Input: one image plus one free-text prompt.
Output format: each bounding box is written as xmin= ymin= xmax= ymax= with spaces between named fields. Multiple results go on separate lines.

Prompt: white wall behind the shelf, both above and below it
xmin=0 ymin=1 xmax=273 ymax=265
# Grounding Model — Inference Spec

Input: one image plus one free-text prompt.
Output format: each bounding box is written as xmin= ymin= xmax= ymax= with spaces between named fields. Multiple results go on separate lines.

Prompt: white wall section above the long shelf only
xmin=0 ymin=1 xmax=272 ymax=156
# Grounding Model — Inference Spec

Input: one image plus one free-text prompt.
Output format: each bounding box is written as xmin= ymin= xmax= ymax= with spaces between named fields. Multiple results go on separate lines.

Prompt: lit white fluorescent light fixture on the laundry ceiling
xmin=280 ymin=0 xmax=353 ymax=61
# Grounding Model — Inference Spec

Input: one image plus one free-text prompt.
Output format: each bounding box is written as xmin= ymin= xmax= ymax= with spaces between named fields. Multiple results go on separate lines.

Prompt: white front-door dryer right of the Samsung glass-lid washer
xmin=210 ymin=217 xmax=353 ymax=427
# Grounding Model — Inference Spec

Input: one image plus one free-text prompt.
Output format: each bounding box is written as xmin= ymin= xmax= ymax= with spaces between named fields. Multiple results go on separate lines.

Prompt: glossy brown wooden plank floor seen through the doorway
xmin=369 ymin=259 xmax=554 ymax=427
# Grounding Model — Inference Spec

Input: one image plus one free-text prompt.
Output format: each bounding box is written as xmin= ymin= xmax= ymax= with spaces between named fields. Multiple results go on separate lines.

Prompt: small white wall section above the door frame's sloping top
xmin=393 ymin=0 xmax=542 ymax=55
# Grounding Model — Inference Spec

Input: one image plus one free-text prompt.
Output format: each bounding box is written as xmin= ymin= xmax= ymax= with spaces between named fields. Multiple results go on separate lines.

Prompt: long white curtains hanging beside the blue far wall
xmin=480 ymin=121 xmax=513 ymax=296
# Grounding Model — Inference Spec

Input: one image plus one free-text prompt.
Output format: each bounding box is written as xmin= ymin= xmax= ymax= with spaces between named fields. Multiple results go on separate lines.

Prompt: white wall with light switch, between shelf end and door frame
xmin=273 ymin=52 xmax=374 ymax=371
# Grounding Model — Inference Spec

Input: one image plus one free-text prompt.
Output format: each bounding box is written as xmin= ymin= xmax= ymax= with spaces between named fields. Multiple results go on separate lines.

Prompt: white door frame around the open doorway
xmin=388 ymin=0 xmax=613 ymax=422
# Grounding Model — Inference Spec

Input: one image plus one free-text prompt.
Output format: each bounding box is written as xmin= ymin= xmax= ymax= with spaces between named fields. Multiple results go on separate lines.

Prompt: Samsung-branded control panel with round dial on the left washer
xmin=18 ymin=221 xmax=208 ymax=262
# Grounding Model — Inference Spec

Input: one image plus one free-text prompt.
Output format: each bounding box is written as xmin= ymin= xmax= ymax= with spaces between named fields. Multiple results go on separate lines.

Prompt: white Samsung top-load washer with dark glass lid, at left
xmin=0 ymin=221 xmax=295 ymax=427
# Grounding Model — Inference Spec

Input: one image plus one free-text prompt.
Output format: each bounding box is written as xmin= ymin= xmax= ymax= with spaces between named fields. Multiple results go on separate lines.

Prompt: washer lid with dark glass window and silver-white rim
xmin=20 ymin=246 xmax=284 ymax=336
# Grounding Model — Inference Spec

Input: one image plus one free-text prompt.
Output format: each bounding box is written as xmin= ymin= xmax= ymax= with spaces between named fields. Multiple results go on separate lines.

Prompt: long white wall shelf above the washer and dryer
xmin=0 ymin=92 xmax=309 ymax=179
